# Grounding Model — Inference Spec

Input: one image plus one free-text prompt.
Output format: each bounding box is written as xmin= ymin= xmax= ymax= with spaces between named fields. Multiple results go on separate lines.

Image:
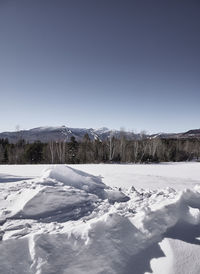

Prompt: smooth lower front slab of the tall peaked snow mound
xmin=12 ymin=187 xmax=98 ymax=222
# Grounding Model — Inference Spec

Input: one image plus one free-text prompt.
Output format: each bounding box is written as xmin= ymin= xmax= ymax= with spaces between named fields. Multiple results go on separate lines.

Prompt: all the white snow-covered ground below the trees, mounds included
xmin=0 ymin=163 xmax=200 ymax=274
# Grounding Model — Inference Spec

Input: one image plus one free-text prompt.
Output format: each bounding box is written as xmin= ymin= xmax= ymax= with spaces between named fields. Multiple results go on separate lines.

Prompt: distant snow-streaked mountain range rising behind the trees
xmin=0 ymin=126 xmax=200 ymax=143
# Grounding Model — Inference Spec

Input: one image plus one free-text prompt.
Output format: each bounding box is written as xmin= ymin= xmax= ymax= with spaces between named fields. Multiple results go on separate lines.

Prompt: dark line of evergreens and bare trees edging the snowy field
xmin=0 ymin=134 xmax=200 ymax=164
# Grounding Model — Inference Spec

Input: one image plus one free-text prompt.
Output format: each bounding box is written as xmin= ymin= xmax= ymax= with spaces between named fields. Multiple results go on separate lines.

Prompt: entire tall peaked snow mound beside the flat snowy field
xmin=0 ymin=166 xmax=129 ymax=223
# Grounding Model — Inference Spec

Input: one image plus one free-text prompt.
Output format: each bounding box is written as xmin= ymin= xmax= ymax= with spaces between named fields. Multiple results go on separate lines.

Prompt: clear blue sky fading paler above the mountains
xmin=0 ymin=0 xmax=200 ymax=133
